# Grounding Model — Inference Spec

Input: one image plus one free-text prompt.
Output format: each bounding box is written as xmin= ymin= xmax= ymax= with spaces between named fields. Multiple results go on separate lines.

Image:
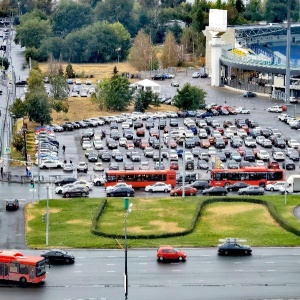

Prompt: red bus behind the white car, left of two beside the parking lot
xmin=105 ymin=170 xmax=176 ymax=188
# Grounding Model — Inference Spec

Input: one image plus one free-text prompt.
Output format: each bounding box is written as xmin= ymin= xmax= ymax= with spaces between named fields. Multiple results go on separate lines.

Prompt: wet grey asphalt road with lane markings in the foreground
xmin=0 ymin=248 xmax=300 ymax=300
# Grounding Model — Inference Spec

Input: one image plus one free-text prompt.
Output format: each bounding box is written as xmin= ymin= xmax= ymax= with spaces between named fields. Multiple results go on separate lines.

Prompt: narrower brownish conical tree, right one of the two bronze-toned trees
xmin=160 ymin=31 xmax=179 ymax=68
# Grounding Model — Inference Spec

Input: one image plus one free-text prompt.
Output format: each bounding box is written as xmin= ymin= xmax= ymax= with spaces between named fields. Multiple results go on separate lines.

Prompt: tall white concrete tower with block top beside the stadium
xmin=208 ymin=9 xmax=227 ymax=86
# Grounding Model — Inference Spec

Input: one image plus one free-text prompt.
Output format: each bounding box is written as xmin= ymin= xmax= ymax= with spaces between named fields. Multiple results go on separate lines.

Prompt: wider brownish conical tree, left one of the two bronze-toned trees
xmin=129 ymin=30 xmax=157 ymax=71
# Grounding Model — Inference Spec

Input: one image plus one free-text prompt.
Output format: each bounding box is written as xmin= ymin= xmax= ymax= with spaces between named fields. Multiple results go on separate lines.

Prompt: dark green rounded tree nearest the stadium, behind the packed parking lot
xmin=173 ymin=83 xmax=206 ymax=110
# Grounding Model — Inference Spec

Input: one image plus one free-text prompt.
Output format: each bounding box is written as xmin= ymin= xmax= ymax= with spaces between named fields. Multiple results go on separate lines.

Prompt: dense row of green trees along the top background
xmin=7 ymin=0 xmax=300 ymax=63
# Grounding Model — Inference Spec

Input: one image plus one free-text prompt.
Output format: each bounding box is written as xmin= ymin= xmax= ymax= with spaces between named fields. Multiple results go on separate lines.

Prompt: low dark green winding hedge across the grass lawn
xmin=91 ymin=197 xmax=300 ymax=239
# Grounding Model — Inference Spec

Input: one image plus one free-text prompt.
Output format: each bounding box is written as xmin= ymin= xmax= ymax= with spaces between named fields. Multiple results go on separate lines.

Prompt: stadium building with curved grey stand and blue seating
xmin=204 ymin=17 xmax=300 ymax=100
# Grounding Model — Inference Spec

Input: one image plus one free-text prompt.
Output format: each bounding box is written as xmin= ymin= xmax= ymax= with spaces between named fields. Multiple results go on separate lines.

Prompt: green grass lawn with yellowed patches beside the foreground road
xmin=25 ymin=195 xmax=300 ymax=248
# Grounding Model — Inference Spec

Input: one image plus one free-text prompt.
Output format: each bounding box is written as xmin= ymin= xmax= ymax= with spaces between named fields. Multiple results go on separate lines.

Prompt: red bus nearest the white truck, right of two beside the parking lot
xmin=211 ymin=167 xmax=284 ymax=187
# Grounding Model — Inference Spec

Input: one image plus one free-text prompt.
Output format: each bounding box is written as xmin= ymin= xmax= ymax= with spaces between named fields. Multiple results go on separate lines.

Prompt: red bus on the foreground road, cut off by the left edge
xmin=0 ymin=250 xmax=46 ymax=283
